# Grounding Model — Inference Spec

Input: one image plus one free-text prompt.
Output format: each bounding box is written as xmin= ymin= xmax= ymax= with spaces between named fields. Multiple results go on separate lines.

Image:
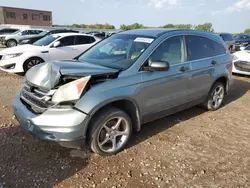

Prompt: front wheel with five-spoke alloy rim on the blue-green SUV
xmin=88 ymin=107 xmax=132 ymax=156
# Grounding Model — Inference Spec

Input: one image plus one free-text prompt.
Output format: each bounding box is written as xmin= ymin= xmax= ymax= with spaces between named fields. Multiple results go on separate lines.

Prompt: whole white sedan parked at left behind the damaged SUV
xmin=0 ymin=33 xmax=100 ymax=73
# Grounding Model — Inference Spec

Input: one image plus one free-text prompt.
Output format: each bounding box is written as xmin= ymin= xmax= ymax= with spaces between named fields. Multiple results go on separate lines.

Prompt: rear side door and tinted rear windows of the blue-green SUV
xmin=186 ymin=35 xmax=226 ymax=100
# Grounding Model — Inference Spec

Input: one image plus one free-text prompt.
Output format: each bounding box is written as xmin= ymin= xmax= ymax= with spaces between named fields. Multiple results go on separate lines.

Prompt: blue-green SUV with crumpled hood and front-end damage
xmin=13 ymin=29 xmax=232 ymax=155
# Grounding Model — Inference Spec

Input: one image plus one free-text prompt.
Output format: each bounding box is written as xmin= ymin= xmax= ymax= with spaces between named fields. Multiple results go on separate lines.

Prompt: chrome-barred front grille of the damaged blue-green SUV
xmin=21 ymin=82 xmax=55 ymax=114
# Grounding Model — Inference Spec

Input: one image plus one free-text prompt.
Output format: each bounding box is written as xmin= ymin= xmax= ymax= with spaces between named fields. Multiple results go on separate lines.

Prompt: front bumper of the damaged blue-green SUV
xmin=13 ymin=95 xmax=90 ymax=148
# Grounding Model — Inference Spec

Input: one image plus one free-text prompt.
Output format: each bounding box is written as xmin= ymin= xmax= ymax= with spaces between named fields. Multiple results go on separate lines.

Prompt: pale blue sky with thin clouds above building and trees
xmin=0 ymin=0 xmax=250 ymax=32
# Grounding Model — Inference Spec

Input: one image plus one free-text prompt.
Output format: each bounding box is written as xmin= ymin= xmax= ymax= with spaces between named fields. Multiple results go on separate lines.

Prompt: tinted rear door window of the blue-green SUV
xmin=187 ymin=36 xmax=213 ymax=61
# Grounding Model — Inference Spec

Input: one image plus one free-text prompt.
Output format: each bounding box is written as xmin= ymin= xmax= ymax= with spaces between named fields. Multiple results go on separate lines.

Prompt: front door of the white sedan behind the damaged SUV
xmin=49 ymin=36 xmax=79 ymax=60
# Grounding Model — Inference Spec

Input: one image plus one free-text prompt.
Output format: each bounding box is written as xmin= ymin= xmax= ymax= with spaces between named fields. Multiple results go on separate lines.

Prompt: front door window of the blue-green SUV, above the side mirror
xmin=149 ymin=36 xmax=187 ymax=65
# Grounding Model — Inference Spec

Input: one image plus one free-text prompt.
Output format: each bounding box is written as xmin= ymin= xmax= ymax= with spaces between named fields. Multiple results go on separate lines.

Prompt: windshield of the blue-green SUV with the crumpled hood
xmin=78 ymin=34 xmax=154 ymax=70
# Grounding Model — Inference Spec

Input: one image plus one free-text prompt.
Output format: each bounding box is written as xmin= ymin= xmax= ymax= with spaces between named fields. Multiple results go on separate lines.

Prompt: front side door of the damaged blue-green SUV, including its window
xmin=140 ymin=36 xmax=191 ymax=122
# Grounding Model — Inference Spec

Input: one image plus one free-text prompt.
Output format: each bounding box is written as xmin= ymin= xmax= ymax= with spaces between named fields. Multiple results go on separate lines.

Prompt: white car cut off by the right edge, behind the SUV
xmin=232 ymin=45 xmax=250 ymax=76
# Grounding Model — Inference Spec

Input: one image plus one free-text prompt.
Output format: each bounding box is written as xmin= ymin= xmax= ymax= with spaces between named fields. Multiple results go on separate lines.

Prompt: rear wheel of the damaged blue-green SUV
xmin=204 ymin=82 xmax=225 ymax=111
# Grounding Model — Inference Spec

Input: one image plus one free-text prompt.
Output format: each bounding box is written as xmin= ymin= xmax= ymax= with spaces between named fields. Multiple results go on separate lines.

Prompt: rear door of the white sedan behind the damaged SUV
xmin=74 ymin=35 xmax=96 ymax=55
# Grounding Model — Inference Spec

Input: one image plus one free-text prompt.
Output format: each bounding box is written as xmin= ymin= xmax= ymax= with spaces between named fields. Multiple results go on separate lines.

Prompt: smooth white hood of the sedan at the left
xmin=0 ymin=44 xmax=46 ymax=54
